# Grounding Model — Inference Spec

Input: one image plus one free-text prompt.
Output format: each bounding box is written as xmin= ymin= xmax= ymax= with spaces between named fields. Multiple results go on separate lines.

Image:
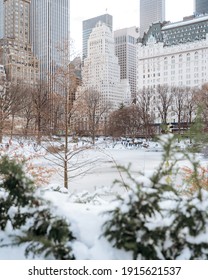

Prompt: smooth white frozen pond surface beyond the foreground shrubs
xmin=57 ymin=149 xmax=162 ymax=195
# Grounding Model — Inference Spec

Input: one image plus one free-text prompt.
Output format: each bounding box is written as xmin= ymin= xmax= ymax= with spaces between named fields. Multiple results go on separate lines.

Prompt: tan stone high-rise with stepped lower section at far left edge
xmin=0 ymin=0 xmax=39 ymax=84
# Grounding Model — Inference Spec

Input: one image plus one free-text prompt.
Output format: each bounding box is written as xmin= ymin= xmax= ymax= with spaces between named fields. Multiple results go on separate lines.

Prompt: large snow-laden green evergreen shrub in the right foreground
xmin=103 ymin=137 xmax=208 ymax=260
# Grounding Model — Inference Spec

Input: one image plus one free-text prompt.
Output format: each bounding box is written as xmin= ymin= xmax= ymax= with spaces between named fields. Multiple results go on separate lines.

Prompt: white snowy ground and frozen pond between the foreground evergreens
xmin=0 ymin=137 xmax=207 ymax=260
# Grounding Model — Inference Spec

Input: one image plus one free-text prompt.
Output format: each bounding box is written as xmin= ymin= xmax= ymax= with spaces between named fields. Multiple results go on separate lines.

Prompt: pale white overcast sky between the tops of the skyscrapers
xmin=70 ymin=0 xmax=194 ymax=52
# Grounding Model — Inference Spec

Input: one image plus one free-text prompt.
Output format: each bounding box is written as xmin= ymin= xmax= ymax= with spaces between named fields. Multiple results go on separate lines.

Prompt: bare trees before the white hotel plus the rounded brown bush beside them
xmin=109 ymin=84 xmax=208 ymax=138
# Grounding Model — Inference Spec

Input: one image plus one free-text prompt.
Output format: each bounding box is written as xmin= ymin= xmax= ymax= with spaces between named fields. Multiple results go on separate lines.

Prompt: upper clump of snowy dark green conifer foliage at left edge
xmin=0 ymin=157 xmax=37 ymax=230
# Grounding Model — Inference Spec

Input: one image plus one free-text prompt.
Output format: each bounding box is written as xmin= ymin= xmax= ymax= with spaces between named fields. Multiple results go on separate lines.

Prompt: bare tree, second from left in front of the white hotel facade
xmin=156 ymin=85 xmax=173 ymax=125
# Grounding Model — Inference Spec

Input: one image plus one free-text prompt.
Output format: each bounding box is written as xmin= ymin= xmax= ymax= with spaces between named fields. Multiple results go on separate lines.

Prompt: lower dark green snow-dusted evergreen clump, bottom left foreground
xmin=15 ymin=209 xmax=75 ymax=260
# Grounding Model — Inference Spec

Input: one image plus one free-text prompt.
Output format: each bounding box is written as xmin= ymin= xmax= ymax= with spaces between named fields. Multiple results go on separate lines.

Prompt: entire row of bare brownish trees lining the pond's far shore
xmin=0 ymin=66 xmax=208 ymax=142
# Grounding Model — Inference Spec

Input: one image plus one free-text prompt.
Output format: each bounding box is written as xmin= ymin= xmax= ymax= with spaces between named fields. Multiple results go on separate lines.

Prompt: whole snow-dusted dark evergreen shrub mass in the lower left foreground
xmin=0 ymin=157 xmax=75 ymax=259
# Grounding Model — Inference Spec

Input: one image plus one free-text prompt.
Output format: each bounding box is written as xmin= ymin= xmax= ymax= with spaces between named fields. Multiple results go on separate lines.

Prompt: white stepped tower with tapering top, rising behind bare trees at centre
xmin=72 ymin=22 xmax=131 ymax=135
